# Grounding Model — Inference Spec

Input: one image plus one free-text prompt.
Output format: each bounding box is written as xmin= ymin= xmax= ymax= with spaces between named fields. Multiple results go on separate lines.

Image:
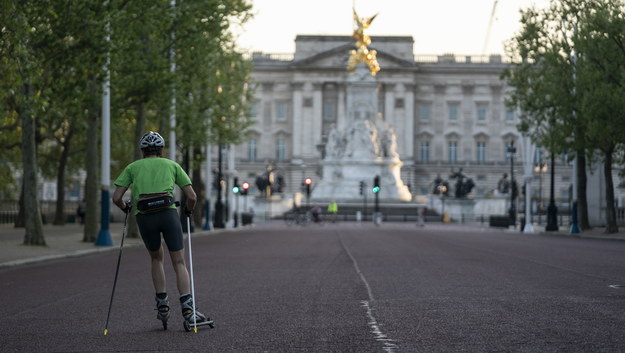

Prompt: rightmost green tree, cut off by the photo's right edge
xmin=575 ymin=0 xmax=625 ymax=233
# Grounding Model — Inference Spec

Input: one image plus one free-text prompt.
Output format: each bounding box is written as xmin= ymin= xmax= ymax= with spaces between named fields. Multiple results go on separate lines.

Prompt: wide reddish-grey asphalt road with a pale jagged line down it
xmin=0 ymin=223 xmax=625 ymax=353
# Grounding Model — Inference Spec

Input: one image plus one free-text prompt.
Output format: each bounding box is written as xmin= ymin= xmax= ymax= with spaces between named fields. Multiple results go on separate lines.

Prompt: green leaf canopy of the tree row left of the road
xmin=0 ymin=0 xmax=251 ymax=204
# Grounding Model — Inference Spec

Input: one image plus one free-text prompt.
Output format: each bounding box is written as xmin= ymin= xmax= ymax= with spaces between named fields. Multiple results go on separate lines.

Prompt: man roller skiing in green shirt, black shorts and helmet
xmin=113 ymin=131 xmax=210 ymax=329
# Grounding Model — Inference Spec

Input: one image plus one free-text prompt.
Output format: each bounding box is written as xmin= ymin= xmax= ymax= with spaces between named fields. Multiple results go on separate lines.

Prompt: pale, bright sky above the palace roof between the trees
xmin=237 ymin=0 xmax=549 ymax=55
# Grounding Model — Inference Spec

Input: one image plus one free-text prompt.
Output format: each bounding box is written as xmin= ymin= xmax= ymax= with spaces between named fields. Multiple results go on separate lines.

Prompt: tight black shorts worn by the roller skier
xmin=137 ymin=208 xmax=184 ymax=251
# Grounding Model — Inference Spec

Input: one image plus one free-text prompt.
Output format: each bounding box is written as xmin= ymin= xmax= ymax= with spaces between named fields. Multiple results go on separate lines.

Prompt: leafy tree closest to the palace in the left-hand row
xmin=167 ymin=0 xmax=252 ymax=226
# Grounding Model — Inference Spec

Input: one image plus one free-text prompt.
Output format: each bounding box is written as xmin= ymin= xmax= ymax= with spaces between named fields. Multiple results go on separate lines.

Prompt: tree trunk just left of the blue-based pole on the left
xmin=82 ymin=77 xmax=100 ymax=243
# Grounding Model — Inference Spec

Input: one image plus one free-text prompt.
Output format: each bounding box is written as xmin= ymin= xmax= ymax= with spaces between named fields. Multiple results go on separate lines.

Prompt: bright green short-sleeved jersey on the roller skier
xmin=115 ymin=157 xmax=191 ymax=214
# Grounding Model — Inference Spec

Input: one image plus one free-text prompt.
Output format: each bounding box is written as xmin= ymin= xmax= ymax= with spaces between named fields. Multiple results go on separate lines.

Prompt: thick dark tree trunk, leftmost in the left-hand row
xmin=19 ymin=83 xmax=46 ymax=246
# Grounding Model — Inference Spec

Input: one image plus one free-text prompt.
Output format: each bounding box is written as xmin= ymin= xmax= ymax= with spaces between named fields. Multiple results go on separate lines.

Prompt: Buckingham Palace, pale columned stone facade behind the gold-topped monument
xmin=228 ymin=35 xmax=571 ymax=207
